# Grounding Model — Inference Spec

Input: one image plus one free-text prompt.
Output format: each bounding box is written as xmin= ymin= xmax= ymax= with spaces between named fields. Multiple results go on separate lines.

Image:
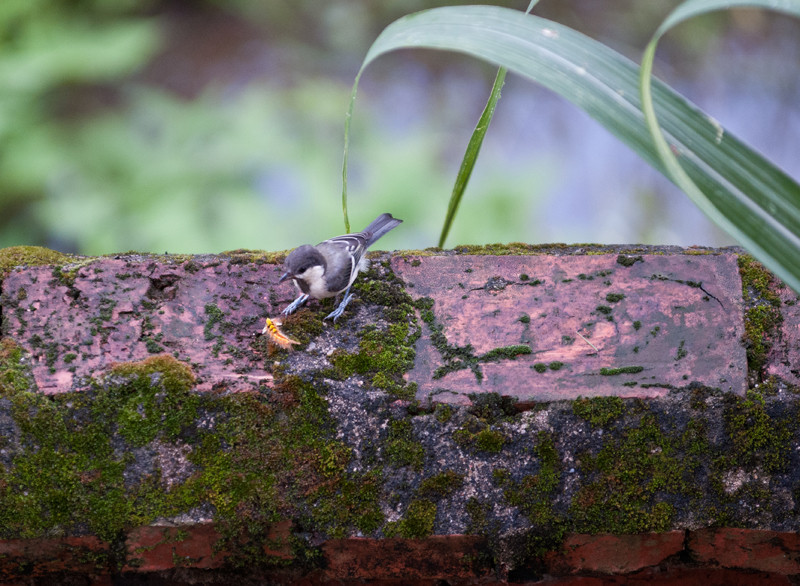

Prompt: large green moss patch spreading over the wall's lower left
xmin=0 ymin=340 xmax=383 ymax=544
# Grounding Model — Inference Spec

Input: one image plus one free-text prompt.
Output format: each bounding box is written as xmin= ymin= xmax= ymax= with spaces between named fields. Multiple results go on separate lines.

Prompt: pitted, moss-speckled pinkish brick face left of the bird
xmin=2 ymin=257 xmax=293 ymax=393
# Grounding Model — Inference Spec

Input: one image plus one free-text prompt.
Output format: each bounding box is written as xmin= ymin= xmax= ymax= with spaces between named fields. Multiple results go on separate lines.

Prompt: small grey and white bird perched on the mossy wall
xmin=278 ymin=214 xmax=403 ymax=322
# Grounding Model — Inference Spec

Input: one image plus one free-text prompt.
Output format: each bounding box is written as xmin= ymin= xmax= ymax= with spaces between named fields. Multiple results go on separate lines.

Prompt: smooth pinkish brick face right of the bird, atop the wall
xmin=392 ymin=254 xmax=747 ymax=404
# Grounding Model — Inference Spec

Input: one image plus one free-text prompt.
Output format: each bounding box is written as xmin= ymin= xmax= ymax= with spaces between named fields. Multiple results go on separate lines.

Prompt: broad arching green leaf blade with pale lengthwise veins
xmin=346 ymin=0 xmax=800 ymax=291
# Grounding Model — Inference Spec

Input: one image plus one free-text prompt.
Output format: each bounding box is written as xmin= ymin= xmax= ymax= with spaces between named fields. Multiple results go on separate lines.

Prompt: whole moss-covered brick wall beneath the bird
xmin=0 ymin=244 xmax=800 ymax=585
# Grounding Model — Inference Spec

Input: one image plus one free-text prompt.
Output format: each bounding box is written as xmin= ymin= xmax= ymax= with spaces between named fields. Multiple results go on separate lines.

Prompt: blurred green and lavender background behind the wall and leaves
xmin=0 ymin=0 xmax=800 ymax=254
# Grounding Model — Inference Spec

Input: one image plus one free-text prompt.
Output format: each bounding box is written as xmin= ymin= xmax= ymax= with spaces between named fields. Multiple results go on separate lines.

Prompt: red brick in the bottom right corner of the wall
xmin=689 ymin=528 xmax=800 ymax=575
